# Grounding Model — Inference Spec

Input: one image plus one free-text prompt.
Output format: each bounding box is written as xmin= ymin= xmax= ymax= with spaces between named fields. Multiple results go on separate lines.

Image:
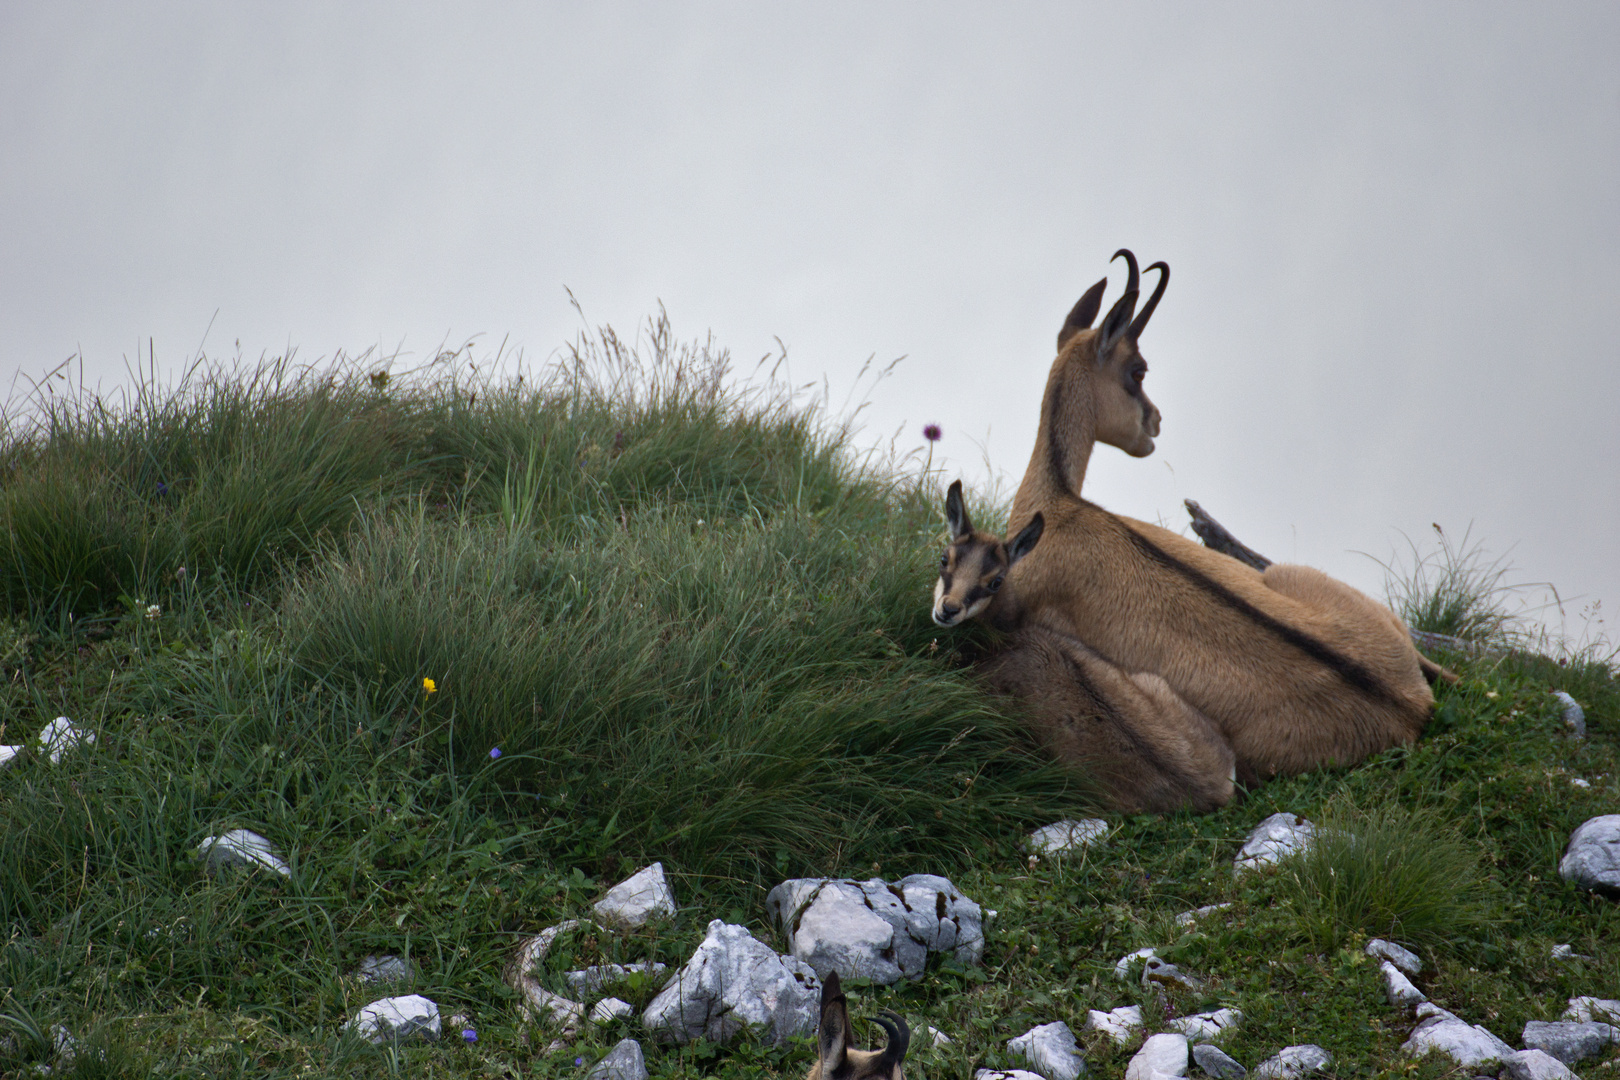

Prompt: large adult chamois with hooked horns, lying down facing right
xmin=988 ymin=251 xmax=1448 ymax=782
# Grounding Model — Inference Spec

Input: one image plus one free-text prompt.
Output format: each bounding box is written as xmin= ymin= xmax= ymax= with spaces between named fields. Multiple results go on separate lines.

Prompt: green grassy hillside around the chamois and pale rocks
xmin=0 ymin=321 xmax=1620 ymax=1078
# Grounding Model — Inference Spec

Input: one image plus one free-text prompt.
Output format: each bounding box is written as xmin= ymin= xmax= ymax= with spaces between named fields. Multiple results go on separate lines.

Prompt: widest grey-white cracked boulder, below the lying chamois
xmin=765 ymin=874 xmax=985 ymax=984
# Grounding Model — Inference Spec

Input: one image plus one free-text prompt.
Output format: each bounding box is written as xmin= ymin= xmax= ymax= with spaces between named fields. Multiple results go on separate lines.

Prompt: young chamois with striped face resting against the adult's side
xmin=933 ymin=481 xmax=1234 ymax=813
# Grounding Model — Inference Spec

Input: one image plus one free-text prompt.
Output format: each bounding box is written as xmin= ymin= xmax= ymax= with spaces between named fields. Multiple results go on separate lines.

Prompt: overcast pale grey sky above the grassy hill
xmin=0 ymin=2 xmax=1620 ymax=647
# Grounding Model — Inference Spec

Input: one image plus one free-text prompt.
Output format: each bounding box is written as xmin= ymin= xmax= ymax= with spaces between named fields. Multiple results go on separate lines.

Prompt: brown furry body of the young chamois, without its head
xmin=983 ymin=627 xmax=1236 ymax=813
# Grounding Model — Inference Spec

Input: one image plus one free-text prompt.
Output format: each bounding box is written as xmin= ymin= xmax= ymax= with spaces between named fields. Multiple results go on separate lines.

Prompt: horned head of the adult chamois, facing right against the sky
xmin=1043 ymin=248 xmax=1170 ymax=463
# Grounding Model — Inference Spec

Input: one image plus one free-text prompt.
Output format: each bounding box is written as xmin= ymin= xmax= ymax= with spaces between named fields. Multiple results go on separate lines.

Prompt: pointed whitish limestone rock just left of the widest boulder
xmin=642 ymin=920 xmax=821 ymax=1046
